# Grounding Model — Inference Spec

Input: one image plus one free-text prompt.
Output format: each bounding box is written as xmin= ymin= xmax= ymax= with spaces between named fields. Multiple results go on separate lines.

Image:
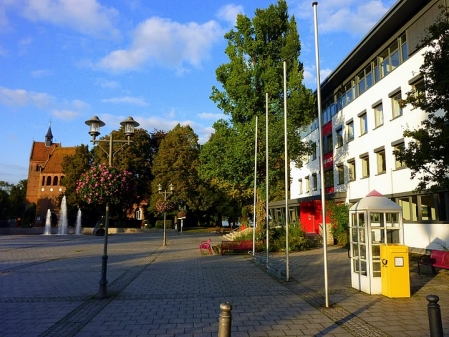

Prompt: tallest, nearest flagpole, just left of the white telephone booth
xmin=312 ymin=2 xmax=329 ymax=308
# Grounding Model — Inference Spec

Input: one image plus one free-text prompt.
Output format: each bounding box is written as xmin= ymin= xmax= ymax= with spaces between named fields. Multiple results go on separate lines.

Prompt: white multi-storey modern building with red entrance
xmin=290 ymin=0 xmax=449 ymax=249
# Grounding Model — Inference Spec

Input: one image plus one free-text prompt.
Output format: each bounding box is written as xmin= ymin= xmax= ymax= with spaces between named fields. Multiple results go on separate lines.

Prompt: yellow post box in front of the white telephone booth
xmin=380 ymin=244 xmax=410 ymax=298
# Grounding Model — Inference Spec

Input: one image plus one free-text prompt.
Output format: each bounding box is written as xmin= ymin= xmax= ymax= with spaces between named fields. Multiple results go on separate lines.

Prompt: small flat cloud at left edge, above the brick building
xmin=0 ymin=87 xmax=54 ymax=108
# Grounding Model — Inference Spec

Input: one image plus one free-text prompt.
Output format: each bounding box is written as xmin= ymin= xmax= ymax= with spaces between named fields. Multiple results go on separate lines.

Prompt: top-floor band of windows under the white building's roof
xmin=302 ymin=33 xmax=408 ymax=137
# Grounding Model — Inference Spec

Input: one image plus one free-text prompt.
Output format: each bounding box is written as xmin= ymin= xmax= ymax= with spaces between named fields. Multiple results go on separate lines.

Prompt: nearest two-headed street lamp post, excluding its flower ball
xmin=85 ymin=116 xmax=139 ymax=298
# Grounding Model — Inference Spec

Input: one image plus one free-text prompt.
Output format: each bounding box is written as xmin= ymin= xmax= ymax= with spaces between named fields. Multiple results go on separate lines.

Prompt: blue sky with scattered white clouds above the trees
xmin=0 ymin=0 xmax=395 ymax=184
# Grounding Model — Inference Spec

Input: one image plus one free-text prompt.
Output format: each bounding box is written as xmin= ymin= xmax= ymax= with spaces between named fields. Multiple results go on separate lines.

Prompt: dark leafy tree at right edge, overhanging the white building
xmin=393 ymin=9 xmax=449 ymax=191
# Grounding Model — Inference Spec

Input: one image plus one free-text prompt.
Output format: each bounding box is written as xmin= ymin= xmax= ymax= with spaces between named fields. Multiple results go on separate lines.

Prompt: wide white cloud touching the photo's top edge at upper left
xmin=21 ymin=0 xmax=119 ymax=37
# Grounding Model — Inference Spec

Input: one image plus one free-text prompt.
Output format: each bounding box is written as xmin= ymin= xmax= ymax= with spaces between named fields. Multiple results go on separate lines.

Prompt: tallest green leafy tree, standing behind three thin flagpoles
xmin=208 ymin=0 xmax=314 ymax=213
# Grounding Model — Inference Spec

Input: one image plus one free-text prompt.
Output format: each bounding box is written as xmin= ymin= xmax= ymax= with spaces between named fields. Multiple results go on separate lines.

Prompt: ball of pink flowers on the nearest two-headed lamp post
xmin=76 ymin=163 xmax=135 ymax=204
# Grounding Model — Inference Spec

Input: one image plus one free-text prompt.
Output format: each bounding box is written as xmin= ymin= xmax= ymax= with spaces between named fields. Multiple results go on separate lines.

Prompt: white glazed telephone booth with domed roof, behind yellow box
xmin=349 ymin=191 xmax=404 ymax=294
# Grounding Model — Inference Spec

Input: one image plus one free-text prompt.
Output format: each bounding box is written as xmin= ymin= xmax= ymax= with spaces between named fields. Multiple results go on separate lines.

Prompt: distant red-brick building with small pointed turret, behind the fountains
xmin=26 ymin=127 xmax=76 ymax=224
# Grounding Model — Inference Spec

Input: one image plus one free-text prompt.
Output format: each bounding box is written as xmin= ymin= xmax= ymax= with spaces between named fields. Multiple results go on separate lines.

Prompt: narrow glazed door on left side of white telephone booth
xmin=349 ymin=212 xmax=371 ymax=294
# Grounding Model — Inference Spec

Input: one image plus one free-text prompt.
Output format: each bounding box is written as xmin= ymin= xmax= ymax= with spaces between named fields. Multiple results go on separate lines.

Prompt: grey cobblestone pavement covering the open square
xmin=0 ymin=232 xmax=449 ymax=337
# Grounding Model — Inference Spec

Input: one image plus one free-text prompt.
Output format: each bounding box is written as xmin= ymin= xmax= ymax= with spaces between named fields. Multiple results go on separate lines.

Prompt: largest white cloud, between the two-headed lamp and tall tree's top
xmin=98 ymin=17 xmax=222 ymax=71
